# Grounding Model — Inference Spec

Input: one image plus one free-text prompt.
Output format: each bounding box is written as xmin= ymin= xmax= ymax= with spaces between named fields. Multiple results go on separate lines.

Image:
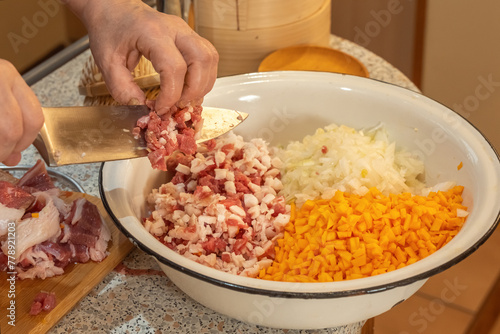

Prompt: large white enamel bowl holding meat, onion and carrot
xmin=100 ymin=72 xmax=500 ymax=329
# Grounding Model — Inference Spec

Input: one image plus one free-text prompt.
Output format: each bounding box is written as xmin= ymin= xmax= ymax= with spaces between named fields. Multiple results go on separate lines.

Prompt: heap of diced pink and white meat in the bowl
xmin=144 ymin=132 xmax=290 ymax=276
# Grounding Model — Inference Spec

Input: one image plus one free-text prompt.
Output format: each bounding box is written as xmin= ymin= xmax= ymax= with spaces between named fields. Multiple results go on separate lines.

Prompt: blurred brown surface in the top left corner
xmin=0 ymin=0 xmax=86 ymax=72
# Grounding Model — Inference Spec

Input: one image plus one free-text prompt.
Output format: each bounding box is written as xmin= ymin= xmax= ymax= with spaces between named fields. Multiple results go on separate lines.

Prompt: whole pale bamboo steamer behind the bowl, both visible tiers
xmin=194 ymin=0 xmax=331 ymax=77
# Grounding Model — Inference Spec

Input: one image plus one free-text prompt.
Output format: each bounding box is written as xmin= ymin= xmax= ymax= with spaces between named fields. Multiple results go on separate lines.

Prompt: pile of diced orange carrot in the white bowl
xmin=258 ymin=186 xmax=467 ymax=282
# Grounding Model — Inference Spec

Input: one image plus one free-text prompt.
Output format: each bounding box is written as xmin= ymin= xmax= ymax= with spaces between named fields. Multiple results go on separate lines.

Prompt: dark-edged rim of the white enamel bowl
xmin=98 ymin=71 xmax=500 ymax=299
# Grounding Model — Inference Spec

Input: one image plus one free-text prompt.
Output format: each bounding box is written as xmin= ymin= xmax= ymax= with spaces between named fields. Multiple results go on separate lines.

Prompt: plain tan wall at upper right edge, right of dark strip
xmin=422 ymin=0 xmax=500 ymax=150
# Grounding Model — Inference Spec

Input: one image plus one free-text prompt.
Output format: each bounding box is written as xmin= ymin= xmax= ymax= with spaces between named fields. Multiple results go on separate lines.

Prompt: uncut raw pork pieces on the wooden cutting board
xmin=0 ymin=160 xmax=111 ymax=279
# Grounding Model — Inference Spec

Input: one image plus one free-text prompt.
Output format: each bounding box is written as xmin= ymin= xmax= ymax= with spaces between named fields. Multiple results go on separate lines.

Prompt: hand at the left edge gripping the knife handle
xmin=0 ymin=59 xmax=44 ymax=166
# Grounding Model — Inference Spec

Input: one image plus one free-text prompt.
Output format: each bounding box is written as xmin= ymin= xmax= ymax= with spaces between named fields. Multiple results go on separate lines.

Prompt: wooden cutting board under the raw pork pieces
xmin=0 ymin=192 xmax=134 ymax=334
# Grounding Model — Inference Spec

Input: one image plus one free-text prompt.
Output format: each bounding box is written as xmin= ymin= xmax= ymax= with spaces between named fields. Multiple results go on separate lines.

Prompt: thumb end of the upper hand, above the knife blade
xmin=101 ymin=61 xmax=146 ymax=104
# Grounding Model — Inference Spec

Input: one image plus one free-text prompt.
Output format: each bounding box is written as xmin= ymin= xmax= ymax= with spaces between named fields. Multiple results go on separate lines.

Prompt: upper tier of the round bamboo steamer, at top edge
xmin=194 ymin=0 xmax=325 ymax=30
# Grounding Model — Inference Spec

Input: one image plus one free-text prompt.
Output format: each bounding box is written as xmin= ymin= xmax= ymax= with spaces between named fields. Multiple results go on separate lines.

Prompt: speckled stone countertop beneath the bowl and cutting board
xmin=15 ymin=36 xmax=418 ymax=334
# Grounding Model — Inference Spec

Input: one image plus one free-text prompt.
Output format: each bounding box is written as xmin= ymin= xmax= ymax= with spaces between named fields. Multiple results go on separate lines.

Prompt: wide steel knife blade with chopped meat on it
xmin=33 ymin=105 xmax=248 ymax=167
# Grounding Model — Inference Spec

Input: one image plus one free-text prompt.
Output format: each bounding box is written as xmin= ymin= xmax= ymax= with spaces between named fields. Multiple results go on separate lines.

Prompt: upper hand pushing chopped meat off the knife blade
xmin=67 ymin=0 xmax=219 ymax=114
